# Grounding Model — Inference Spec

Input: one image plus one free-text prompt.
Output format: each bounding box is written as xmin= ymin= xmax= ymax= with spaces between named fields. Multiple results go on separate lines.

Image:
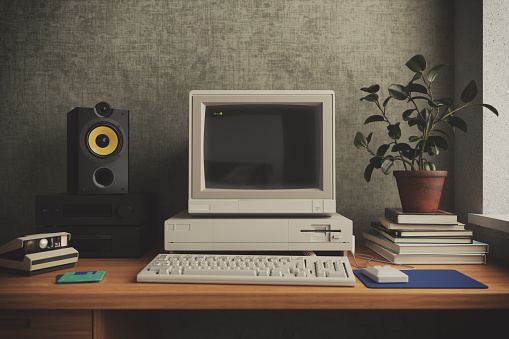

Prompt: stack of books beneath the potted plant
xmin=363 ymin=208 xmax=488 ymax=264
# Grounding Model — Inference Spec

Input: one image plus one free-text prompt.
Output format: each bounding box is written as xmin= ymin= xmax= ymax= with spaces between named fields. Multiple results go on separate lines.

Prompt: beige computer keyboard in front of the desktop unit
xmin=137 ymin=254 xmax=355 ymax=286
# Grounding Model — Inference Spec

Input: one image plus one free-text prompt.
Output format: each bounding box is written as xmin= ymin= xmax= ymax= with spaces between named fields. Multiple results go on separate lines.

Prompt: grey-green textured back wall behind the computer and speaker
xmin=0 ymin=0 xmax=454 ymax=242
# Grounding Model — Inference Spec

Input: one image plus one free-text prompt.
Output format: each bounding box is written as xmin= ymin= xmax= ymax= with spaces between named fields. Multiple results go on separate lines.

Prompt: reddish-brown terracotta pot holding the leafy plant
xmin=393 ymin=171 xmax=447 ymax=213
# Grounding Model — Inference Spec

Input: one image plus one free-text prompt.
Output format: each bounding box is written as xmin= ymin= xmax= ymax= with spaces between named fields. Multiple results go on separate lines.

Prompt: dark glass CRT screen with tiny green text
xmin=203 ymin=104 xmax=322 ymax=190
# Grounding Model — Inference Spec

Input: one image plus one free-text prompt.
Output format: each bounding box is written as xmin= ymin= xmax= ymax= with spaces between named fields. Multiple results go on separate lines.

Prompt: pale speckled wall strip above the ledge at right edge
xmin=482 ymin=0 xmax=509 ymax=214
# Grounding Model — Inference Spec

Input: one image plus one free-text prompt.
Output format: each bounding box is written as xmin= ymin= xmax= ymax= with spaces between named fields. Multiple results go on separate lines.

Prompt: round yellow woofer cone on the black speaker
xmin=85 ymin=124 xmax=122 ymax=158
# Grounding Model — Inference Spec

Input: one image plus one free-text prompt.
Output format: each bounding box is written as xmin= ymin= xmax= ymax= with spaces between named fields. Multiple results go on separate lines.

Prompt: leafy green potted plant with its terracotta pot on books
xmin=354 ymin=55 xmax=498 ymax=213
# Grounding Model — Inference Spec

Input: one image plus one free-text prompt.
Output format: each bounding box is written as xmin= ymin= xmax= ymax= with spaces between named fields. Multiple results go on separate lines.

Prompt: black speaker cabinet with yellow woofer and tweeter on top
xmin=67 ymin=102 xmax=129 ymax=194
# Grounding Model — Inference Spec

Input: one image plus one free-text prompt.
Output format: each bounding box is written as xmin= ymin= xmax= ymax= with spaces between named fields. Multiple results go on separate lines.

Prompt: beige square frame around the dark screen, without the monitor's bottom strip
xmin=189 ymin=90 xmax=335 ymax=200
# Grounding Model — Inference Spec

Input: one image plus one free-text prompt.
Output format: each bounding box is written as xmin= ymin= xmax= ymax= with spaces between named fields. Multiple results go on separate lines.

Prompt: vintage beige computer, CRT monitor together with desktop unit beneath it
xmin=164 ymin=91 xmax=354 ymax=251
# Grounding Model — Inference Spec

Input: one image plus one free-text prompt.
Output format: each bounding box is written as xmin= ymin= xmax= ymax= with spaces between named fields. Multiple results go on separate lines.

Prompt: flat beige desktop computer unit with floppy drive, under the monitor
xmin=164 ymin=211 xmax=354 ymax=251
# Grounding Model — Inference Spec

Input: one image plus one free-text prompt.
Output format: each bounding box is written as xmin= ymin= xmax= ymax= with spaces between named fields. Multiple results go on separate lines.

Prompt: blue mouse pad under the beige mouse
xmin=353 ymin=270 xmax=488 ymax=288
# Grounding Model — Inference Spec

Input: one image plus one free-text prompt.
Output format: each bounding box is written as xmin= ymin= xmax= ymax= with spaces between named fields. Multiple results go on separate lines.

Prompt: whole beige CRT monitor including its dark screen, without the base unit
xmin=188 ymin=90 xmax=336 ymax=215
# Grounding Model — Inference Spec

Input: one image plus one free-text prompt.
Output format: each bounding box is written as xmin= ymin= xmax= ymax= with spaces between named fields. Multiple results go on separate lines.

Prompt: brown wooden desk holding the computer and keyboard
xmin=0 ymin=246 xmax=509 ymax=338
